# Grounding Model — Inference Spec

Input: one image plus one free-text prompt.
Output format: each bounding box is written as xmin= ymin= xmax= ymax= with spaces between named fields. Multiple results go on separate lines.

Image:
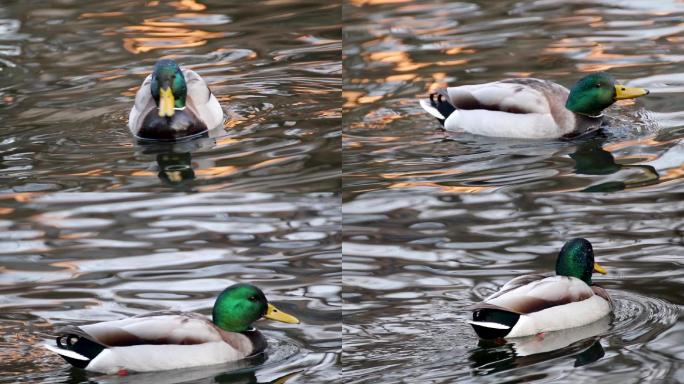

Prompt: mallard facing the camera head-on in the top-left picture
xmin=128 ymin=59 xmax=223 ymax=141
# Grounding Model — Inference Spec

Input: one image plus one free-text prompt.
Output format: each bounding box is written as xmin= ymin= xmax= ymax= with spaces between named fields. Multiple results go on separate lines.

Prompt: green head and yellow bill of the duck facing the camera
xmin=150 ymin=59 xmax=188 ymax=117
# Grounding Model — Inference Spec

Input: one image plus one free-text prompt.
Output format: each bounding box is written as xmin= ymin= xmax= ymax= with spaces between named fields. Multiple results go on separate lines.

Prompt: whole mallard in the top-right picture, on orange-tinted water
xmin=420 ymin=72 xmax=648 ymax=139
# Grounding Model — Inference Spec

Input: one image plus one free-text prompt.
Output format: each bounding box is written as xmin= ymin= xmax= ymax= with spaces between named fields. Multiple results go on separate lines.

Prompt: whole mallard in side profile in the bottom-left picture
xmin=45 ymin=284 xmax=299 ymax=374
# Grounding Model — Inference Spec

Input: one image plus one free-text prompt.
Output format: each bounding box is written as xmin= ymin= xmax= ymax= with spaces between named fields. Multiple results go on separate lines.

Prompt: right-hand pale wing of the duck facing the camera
xmin=182 ymin=68 xmax=223 ymax=129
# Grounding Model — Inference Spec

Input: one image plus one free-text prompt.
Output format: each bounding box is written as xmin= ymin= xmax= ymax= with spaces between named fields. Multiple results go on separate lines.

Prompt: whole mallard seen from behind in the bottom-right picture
xmin=468 ymin=238 xmax=613 ymax=339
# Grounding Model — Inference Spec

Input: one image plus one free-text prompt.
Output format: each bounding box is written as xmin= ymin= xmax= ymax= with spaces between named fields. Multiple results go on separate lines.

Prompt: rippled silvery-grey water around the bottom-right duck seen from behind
xmin=343 ymin=190 xmax=684 ymax=383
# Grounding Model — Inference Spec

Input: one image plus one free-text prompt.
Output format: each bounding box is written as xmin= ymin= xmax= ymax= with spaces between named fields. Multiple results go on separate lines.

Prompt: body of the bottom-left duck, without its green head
xmin=42 ymin=312 xmax=266 ymax=374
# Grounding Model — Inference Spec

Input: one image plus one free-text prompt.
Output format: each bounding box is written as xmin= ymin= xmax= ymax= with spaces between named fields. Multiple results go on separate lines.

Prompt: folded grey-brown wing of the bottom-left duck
xmin=76 ymin=314 xmax=223 ymax=347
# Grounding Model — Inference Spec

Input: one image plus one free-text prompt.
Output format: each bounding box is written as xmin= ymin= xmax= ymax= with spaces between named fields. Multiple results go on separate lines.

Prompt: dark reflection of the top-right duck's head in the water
xmin=570 ymin=131 xmax=660 ymax=192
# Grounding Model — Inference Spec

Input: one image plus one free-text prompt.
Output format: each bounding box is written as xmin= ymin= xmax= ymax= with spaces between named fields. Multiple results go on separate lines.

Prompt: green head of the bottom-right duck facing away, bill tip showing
xmin=556 ymin=238 xmax=606 ymax=284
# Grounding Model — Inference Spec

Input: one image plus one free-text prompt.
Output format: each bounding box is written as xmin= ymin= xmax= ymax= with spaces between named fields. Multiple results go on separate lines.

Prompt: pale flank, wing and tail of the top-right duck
xmin=421 ymin=78 xmax=576 ymax=138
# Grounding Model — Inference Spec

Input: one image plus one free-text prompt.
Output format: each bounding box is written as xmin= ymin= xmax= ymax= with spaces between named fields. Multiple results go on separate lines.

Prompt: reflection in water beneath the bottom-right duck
xmin=469 ymin=316 xmax=611 ymax=375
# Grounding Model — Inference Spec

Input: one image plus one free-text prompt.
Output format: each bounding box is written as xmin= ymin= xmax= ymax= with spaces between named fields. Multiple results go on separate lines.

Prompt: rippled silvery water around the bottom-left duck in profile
xmin=0 ymin=193 xmax=342 ymax=383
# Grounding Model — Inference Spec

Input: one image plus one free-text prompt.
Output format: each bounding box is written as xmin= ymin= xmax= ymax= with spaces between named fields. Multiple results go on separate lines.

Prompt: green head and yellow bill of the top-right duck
xmin=565 ymin=72 xmax=648 ymax=116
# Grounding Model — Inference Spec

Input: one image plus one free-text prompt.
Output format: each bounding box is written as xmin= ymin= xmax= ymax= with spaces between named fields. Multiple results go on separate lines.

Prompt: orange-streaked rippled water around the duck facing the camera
xmin=0 ymin=0 xmax=341 ymax=192
